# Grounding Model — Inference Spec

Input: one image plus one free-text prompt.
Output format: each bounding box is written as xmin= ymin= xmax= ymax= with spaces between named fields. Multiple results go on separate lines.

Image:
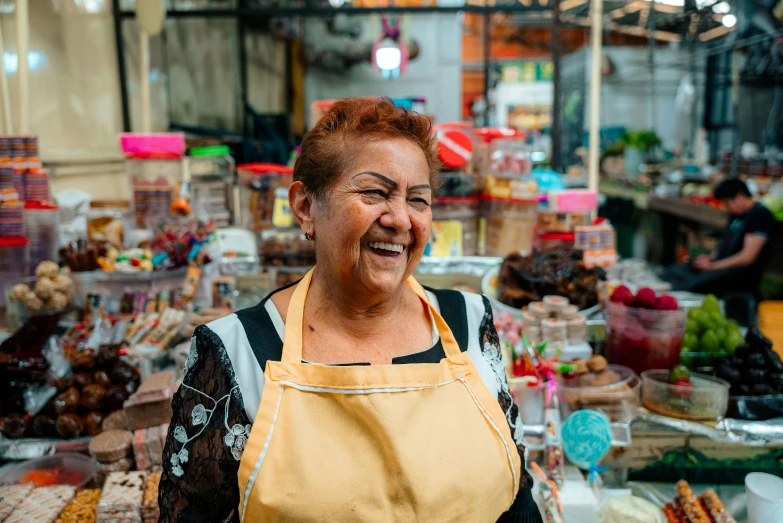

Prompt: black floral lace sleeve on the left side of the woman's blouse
xmin=158 ymin=325 xmax=251 ymax=522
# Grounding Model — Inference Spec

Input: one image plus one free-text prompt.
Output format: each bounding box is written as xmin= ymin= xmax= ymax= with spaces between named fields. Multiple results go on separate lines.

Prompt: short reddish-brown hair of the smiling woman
xmin=294 ymin=97 xmax=441 ymax=198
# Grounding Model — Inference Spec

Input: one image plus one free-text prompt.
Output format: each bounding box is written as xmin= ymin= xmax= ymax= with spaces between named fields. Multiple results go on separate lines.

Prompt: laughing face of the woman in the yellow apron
xmin=312 ymin=138 xmax=432 ymax=293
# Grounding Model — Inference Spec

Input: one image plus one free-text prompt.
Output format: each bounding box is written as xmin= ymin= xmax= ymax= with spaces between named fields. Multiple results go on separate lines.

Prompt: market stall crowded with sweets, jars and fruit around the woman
xmin=0 ymin=116 xmax=783 ymax=523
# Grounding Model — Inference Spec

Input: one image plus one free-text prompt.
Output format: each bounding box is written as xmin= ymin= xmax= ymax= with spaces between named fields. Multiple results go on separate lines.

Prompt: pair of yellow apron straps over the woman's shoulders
xmin=281 ymin=269 xmax=460 ymax=363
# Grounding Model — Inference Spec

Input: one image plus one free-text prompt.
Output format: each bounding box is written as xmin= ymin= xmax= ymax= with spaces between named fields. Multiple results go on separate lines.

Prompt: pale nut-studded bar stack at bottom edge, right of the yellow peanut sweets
xmin=95 ymin=472 xmax=147 ymax=523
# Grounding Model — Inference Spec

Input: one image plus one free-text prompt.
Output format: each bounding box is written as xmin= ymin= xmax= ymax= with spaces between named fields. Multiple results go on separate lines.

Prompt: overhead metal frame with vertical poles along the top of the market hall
xmin=113 ymin=0 xmax=730 ymax=185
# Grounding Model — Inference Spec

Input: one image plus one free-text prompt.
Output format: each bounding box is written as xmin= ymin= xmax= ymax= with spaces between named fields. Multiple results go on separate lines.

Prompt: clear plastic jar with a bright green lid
xmin=187 ymin=145 xmax=235 ymax=227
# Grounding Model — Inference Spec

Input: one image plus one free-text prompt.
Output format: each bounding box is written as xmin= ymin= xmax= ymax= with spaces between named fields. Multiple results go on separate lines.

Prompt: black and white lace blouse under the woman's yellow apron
xmin=159 ymin=291 xmax=542 ymax=523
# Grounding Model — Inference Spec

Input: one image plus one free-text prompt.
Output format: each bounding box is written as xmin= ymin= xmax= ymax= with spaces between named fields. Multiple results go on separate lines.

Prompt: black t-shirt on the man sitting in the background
xmin=717 ymin=203 xmax=780 ymax=278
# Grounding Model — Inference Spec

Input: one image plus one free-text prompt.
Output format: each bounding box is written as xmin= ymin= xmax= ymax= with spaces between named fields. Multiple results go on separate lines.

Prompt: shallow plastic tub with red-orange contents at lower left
xmin=0 ymin=452 xmax=95 ymax=488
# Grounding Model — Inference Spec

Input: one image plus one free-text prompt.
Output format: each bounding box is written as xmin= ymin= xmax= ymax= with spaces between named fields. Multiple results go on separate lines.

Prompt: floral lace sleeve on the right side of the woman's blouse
xmin=479 ymin=297 xmax=543 ymax=523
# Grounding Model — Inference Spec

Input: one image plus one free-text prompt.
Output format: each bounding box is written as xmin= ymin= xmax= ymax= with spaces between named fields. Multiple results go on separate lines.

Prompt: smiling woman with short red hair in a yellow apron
xmin=160 ymin=99 xmax=541 ymax=523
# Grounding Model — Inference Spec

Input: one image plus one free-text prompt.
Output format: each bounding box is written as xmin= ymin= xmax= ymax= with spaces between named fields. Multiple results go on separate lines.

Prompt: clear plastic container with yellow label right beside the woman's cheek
xmin=430 ymin=197 xmax=479 ymax=256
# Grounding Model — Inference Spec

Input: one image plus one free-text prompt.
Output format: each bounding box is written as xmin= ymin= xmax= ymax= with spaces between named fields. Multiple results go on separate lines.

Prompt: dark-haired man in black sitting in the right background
xmin=662 ymin=178 xmax=780 ymax=296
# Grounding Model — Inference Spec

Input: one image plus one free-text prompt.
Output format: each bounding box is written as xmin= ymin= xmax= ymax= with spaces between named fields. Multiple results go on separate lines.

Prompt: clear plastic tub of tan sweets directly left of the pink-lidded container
xmin=483 ymin=197 xmax=538 ymax=256
